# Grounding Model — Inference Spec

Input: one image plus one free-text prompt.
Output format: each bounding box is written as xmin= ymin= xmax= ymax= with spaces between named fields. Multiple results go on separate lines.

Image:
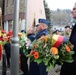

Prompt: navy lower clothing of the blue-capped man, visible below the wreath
xmin=29 ymin=61 xmax=48 ymax=75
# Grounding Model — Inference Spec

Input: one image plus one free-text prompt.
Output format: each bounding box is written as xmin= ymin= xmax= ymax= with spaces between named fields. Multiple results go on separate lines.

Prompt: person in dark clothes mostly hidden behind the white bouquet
xmin=20 ymin=30 xmax=28 ymax=75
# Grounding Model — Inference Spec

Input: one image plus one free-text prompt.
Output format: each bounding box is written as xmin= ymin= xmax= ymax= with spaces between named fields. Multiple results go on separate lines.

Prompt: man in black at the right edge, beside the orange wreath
xmin=60 ymin=3 xmax=76 ymax=75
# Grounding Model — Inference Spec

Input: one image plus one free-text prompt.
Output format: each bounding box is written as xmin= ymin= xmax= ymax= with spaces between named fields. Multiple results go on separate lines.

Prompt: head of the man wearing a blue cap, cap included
xmin=36 ymin=19 xmax=50 ymax=32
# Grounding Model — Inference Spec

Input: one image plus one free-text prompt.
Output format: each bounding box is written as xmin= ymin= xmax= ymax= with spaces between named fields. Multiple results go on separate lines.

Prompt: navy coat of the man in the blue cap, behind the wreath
xmin=29 ymin=29 xmax=48 ymax=75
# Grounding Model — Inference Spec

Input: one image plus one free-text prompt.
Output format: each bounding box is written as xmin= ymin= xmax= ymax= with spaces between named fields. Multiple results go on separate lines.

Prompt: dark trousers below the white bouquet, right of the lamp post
xmin=20 ymin=55 xmax=28 ymax=75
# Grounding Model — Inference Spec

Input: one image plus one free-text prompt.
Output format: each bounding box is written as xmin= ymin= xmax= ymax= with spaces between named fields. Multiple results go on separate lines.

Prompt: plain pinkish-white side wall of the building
xmin=26 ymin=0 xmax=46 ymax=29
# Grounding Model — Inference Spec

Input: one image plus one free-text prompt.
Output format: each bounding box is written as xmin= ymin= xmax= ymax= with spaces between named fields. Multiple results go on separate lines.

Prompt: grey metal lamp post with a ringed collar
xmin=10 ymin=0 xmax=20 ymax=75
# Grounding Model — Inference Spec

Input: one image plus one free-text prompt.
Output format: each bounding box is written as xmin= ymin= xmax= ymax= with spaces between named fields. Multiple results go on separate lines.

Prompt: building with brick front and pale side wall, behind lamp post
xmin=0 ymin=0 xmax=45 ymax=32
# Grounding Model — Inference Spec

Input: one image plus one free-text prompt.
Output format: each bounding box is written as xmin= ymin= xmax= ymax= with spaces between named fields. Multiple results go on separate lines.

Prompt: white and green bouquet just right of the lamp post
xmin=18 ymin=33 xmax=31 ymax=55
